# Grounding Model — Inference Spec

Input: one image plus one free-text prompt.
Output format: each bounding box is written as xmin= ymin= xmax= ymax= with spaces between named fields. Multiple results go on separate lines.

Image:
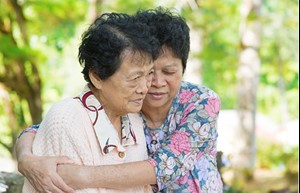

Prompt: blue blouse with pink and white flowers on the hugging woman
xmin=145 ymin=82 xmax=223 ymax=193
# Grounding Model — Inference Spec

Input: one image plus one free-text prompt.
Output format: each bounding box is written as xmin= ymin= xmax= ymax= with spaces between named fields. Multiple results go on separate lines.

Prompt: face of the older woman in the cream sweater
xmin=93 ymin=50 xmax=153 ymax=116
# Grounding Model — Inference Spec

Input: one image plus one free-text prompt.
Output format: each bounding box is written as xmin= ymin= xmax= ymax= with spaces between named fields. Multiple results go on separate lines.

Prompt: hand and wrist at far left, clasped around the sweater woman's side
xmin=15 ymin=126 xmax=74 ymax=192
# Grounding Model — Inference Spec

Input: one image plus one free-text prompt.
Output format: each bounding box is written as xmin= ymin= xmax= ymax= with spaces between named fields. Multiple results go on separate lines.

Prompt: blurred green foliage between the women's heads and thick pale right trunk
xmin=183 ymin=0 xmax=240 ymax=109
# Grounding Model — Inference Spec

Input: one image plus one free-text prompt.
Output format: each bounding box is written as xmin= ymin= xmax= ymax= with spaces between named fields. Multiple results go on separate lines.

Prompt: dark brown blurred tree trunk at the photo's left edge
xmin=0 ymin=0 xmax=42 ymax=155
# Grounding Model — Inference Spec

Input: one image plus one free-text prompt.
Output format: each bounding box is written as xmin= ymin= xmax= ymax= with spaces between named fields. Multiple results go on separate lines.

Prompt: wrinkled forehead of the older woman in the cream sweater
xmin=121 ymin=48 xmax=153 ymax=66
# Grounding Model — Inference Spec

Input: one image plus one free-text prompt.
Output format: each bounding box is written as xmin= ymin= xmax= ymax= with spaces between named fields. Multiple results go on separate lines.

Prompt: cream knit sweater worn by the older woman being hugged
xmin=23 ymin=98 xmax=152 ymax=193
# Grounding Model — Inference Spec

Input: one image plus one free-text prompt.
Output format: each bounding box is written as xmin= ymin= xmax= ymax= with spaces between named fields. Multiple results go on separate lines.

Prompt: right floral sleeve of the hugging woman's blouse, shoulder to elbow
xmin=148 ymin=96 xmax=220 ymax=190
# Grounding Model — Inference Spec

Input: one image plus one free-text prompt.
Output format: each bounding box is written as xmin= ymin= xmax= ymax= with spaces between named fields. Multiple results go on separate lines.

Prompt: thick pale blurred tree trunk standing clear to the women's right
xmin=233 ymin=0 xmax=261 ymax=178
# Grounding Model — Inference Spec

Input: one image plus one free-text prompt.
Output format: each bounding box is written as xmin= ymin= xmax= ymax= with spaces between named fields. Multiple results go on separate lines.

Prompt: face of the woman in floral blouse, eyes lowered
xmin=143 ymin=47 xmax=183 ymax=111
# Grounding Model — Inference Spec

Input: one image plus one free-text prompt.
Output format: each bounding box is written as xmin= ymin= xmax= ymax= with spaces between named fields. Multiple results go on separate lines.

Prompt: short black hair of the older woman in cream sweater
xmin=78 ymin=12 xmax=159 ymax=84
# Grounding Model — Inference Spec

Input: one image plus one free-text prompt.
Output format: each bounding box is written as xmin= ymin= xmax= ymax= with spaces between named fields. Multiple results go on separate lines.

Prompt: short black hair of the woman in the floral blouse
xmin=135 ymin=7 xmax=190 ymax=72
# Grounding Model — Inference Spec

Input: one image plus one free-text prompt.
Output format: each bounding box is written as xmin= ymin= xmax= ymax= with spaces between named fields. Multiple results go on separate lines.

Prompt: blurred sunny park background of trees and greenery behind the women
xmin=0 ymin=0 xmax=299 ymax=193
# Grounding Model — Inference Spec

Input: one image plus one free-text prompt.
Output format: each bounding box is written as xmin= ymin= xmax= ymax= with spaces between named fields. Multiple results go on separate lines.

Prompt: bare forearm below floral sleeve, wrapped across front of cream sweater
xmin=58 ymin=161 xmax=156 ymax=189
